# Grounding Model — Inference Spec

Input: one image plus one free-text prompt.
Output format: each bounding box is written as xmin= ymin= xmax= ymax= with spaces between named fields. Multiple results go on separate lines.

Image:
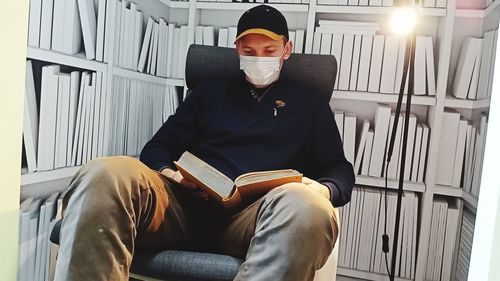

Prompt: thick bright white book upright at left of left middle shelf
xmin=37 ymin=65 xmax=60 ymax=171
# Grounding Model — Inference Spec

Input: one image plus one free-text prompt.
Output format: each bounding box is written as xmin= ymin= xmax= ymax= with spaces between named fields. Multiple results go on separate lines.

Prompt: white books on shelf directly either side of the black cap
xmin=194 ymin=25 xmax=305 ymax=53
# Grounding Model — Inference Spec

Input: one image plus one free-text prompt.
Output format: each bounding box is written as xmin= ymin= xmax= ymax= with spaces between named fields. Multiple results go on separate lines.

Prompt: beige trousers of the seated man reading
xmin=56 ymin=156 xmax=338 ymax=281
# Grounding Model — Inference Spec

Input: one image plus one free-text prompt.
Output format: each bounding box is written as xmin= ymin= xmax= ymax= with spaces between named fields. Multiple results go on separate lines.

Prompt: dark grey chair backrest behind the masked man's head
xmin=186 ymin=45 xmax=337 ymax=103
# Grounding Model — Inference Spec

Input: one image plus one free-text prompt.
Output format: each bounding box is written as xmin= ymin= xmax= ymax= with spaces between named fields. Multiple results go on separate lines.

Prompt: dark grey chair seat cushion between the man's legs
xmin=131 ymin=250 xmax=243 ymax=281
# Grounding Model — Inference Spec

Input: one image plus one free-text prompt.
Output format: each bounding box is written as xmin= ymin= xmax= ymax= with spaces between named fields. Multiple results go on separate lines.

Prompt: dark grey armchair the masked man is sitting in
xmin=51 ymin=45 xmax=337 ymax=281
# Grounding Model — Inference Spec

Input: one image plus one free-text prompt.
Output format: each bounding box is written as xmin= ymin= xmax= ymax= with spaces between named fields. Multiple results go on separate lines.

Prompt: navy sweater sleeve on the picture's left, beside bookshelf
xmin=140 ymin=89 xmax=201 ymax=171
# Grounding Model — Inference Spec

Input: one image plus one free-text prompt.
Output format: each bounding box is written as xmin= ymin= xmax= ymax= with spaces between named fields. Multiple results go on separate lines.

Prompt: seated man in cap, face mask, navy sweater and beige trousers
xmin=56 ymin=5 xmax=354 ymax=281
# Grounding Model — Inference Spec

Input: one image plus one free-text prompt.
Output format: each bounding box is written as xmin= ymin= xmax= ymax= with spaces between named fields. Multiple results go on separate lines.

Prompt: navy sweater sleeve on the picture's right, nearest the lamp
xmin=306 ymin=98 xmax=355 ymax=207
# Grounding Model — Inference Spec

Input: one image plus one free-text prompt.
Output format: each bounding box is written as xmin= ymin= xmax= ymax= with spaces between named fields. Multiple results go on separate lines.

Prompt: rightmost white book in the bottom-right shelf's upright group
xmin=439 ymin=203 xmax=459 ymax=280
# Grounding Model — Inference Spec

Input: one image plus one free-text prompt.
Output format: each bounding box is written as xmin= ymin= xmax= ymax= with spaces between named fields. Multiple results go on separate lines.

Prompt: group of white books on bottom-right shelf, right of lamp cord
xmin=425 ymin=198 xmax=459 ymax=281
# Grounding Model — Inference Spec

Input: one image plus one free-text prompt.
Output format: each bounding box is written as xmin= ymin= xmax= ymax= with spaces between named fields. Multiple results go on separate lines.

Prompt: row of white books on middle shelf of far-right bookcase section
xmin=436 ymin=111 xmax=488 ymax=196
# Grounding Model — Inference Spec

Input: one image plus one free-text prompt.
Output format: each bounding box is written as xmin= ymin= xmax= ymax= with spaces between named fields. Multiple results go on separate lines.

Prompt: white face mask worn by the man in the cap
xmin=240 ymin=55 xmax=281 ymax=87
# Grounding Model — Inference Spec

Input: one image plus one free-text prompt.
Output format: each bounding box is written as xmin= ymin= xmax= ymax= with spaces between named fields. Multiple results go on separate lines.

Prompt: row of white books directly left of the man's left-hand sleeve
xmin=107 ymin=76 xmax=179 ymax=156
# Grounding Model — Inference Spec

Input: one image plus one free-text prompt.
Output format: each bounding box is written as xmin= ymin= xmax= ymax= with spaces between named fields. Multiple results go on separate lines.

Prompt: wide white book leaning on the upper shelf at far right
xmin=452 ymin=37 xmax=482 ymax=99
